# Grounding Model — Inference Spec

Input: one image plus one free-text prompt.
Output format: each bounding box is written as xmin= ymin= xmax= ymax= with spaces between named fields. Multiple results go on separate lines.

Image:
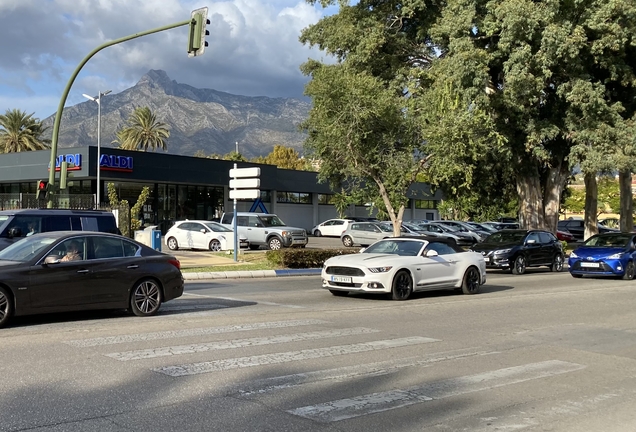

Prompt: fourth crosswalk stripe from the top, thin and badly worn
xmin=232 ymin=348 xmax=500 ymax=396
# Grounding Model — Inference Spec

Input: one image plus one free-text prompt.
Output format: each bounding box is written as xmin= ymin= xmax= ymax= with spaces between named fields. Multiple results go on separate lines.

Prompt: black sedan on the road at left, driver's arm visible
xmin=0 ymin=231 xmax=183 ymax=327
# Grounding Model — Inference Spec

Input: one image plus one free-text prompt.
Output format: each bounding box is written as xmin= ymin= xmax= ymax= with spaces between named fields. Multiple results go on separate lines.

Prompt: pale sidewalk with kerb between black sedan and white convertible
xmin=166 ymin=250 xmax=321 ymax=281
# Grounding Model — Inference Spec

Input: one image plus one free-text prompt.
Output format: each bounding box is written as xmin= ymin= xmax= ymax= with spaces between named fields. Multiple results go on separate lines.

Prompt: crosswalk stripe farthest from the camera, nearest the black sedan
xmin=64 ymin=319 xmax=327 ymax=348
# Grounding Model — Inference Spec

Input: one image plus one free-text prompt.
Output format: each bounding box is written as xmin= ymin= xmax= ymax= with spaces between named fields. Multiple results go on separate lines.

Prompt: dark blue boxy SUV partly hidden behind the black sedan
xmin=0 ymin=209 xmax=121 ymax=250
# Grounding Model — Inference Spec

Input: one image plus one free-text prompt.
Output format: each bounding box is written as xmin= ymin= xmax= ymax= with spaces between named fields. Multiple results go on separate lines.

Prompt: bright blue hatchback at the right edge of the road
xmin=568 ymin=233 xmax=636 ymax=280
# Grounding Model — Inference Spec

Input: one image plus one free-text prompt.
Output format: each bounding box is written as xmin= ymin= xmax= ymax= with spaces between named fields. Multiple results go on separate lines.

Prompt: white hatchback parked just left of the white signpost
xmin=165 ymin=220 xmax=248 ymax=252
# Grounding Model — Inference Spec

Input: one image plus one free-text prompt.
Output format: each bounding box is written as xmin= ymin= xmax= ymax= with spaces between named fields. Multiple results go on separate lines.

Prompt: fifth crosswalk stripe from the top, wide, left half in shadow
xmin=287 ymin=360 xmax=585 ymax=423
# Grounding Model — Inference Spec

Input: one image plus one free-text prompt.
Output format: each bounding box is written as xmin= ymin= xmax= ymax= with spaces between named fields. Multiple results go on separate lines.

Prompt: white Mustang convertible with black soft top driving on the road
xmin=322 ymin=237 xmax=486 ymax=300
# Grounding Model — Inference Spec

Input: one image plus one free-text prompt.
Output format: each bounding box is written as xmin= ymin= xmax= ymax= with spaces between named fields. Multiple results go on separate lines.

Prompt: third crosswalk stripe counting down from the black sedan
xmin=152 ymin=336 xmax=438 ymax=377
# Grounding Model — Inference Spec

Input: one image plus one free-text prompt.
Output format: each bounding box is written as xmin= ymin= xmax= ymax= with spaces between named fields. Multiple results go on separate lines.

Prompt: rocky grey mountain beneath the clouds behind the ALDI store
xmin=43 ymin=70 xmax=311 ymax=158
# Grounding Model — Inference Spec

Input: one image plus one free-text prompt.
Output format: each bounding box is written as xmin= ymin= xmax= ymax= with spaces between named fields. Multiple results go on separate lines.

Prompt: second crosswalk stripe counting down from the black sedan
xmin=106 ymin=327 xmax=380 ymax=361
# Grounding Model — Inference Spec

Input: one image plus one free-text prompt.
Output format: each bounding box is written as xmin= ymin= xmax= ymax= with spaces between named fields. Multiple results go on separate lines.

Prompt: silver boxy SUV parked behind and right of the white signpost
xmin=221 ymin=212 xmax=309 ymax=250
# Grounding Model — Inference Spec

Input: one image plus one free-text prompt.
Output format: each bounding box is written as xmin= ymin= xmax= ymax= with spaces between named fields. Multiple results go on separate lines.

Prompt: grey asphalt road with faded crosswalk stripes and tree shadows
xmin=0 ymin=269 xmax=636 ymax=432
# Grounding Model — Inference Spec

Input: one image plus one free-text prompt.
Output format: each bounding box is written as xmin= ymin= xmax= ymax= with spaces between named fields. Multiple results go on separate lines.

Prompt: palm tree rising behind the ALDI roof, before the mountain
xmin=113 ymin=107 xmax=170 ymax=151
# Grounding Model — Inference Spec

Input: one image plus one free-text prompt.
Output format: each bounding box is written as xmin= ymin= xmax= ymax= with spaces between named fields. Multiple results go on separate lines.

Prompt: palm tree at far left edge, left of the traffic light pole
xmin=0 ymin=109 xmax=51 ymax=153
